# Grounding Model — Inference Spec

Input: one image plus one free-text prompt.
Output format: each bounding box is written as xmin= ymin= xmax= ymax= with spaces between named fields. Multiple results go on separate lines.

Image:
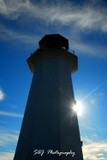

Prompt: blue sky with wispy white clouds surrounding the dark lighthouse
xmin=0 ymin=0 xmax=107 ymax=160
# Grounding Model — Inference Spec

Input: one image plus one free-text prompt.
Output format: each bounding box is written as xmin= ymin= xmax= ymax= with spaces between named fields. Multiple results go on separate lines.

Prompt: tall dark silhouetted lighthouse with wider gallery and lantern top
xmin=14 ymin=34 xmax=83 ymax=160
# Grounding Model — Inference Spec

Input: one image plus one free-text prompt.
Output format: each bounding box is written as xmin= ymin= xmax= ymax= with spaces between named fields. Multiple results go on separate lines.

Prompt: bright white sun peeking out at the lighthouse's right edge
xmin=73 ymin=101 xmax=84 ymax=116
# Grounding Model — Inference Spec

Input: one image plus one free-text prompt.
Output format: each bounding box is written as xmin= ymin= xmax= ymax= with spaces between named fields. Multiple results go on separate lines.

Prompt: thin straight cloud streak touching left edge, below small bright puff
xmin=0 ymin=111 xmax=23 ymax=118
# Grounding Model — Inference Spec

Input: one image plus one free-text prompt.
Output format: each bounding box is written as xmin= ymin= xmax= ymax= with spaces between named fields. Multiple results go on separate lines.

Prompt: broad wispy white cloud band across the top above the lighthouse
xmin=0 ymin=0 xmax=107 ymax=32
